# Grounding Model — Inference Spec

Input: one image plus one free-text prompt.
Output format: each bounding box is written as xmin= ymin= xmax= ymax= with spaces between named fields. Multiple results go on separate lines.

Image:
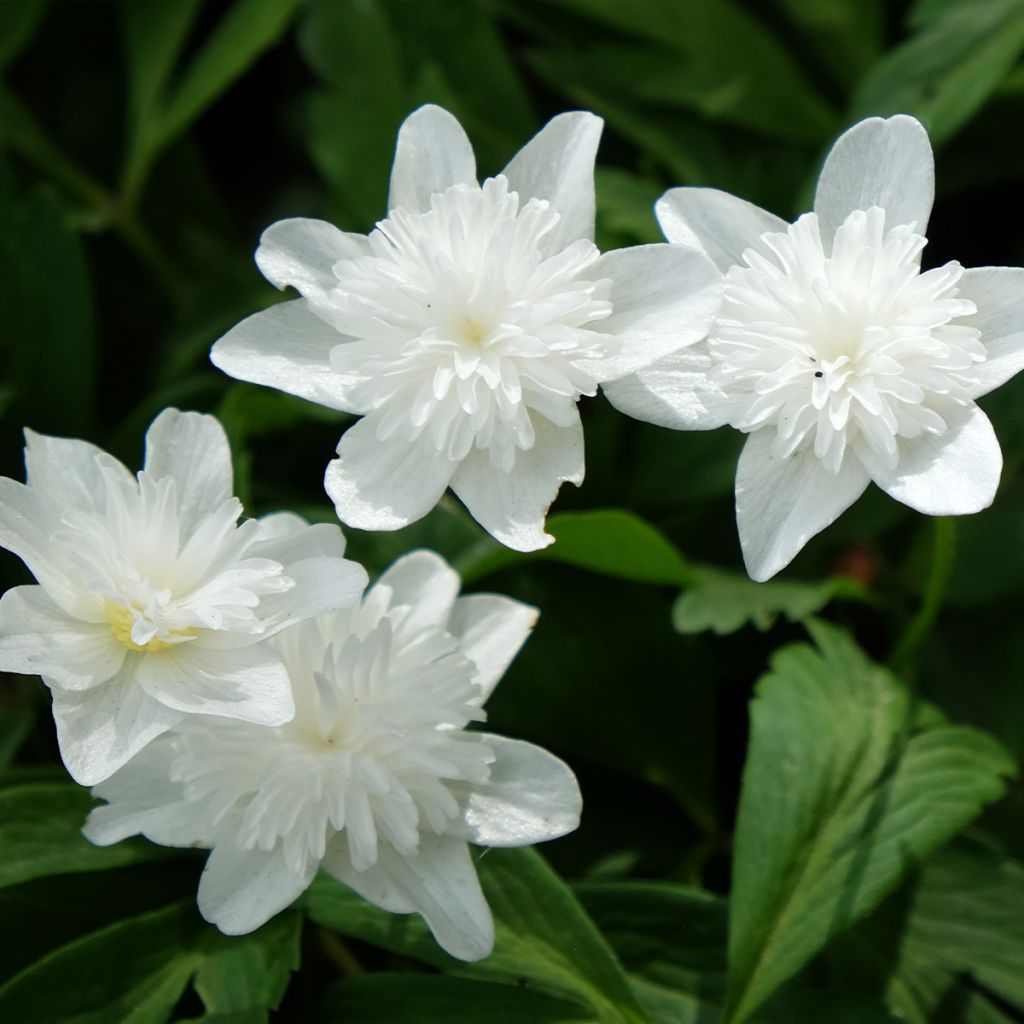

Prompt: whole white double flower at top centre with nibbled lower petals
xmin=211 ymin=106 xmax=721 ymax=551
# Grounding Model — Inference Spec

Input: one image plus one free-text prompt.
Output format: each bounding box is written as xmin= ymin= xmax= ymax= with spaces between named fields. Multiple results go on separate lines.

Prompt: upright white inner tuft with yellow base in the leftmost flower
xmin=53 ymin=472 xmax=295 ymax=651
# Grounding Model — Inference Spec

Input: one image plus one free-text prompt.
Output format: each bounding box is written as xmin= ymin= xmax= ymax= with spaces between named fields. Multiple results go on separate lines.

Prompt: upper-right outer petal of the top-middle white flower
xmin=502 ymin=111 xmax=604 ymax=252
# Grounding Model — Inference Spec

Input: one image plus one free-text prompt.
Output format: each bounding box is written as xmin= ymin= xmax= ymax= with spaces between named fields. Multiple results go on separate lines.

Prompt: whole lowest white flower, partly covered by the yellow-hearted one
xmin=85 ymin=551 xmax=581 ymax=959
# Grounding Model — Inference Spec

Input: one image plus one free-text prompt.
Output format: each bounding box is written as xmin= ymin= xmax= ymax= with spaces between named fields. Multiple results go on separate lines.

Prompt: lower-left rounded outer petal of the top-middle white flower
xmin=324 ymin=416 xmax=458 ymax=529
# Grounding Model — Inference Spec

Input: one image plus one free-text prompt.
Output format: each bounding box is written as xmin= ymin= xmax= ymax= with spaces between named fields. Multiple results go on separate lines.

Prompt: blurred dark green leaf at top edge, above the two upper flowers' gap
xmin=524 ymin=0 xmax=835 ymax=142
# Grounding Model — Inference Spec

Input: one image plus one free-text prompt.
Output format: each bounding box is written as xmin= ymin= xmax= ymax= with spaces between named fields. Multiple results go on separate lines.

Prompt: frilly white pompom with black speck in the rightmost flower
xmin=710 ymin=207 xmax=985 ymax=473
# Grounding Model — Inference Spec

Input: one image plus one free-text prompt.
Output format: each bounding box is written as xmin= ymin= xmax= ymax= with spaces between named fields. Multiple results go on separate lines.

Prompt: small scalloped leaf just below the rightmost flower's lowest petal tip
xmin=672 ymin=566 xmax=864 ymax=636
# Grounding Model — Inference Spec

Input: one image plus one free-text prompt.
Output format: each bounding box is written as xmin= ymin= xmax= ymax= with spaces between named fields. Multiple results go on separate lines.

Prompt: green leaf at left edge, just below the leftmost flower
xmin=0 ymin=783 xmax=166 ymax=888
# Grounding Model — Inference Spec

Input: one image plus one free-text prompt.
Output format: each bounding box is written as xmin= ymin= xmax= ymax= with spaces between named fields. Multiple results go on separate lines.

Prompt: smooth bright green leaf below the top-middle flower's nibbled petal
xmin=458 ymin=509 xmax=690 ymax=585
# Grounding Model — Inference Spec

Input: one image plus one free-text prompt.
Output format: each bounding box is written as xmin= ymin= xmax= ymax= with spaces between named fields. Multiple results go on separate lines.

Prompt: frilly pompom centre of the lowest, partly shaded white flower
xmin=172 ymin=616 xmax=494 ymax=871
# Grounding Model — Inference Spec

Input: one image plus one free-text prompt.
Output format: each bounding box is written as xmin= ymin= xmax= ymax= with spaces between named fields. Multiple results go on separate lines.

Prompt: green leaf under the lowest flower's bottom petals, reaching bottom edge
xmin=301 ymin=848 xmax=643 ymax=1024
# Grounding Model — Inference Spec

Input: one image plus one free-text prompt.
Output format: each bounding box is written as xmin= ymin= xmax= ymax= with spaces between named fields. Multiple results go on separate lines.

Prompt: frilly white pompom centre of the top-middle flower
xmin=316 ymin=176 xmax=611 ymax=469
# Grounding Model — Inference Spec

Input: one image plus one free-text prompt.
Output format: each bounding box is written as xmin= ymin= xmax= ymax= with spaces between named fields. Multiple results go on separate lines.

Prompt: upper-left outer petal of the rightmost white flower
xmin=654 ymin=188 xmax=788 ymax=273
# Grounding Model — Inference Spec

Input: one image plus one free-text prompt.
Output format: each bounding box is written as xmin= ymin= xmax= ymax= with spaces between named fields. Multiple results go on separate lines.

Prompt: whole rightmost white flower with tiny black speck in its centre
xmin=608 ymin=115 xmax=1024 ymax=581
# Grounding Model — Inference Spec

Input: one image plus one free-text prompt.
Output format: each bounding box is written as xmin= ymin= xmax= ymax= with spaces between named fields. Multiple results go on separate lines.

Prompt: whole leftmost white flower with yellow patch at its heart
xmin=0 ymin=409 xmax=367 ymax=785
